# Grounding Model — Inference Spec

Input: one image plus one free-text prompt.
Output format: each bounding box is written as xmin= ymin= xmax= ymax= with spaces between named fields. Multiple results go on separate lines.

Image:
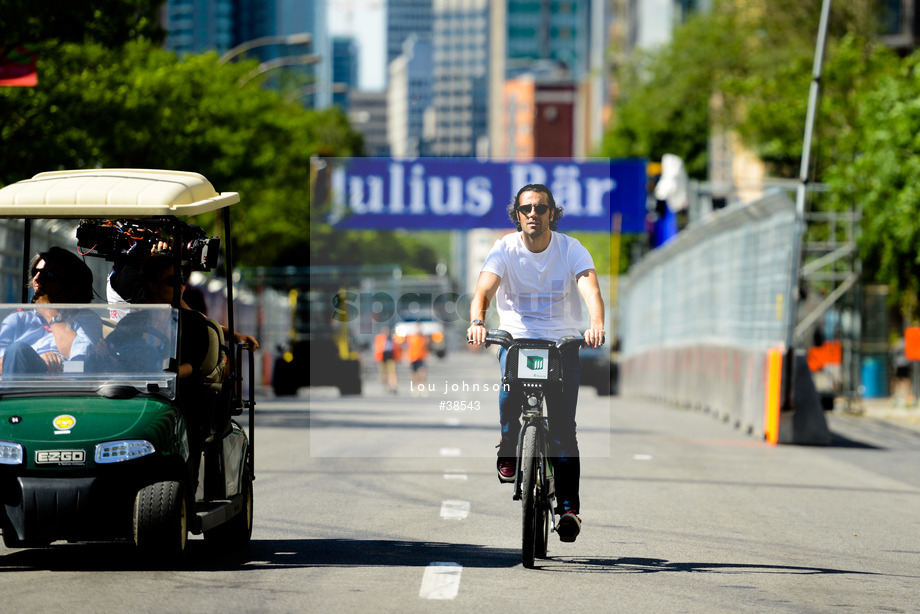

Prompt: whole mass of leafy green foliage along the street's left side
xmin=0 ymin=0 xmax=437 ymax=271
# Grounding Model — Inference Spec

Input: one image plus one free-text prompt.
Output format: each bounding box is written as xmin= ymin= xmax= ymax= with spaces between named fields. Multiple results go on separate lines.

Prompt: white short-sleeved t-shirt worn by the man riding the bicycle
xmin=482 ymin=232 xmax=594 ymax=341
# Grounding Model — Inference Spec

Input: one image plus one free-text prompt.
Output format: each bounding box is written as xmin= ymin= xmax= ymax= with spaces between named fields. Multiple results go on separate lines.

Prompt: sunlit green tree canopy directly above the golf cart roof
xmin=0 ymin=41 xmax=360 ymax=264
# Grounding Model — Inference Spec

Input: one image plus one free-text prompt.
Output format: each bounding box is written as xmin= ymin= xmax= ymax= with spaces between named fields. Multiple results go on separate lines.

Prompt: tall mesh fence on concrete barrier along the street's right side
xmin=620 ymin=191 xmax=799 ymax=435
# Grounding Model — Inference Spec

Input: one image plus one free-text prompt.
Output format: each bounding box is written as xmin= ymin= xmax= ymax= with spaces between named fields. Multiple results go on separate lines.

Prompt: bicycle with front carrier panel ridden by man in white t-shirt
xmin=485 ymin=329 xmax=585 ymax=569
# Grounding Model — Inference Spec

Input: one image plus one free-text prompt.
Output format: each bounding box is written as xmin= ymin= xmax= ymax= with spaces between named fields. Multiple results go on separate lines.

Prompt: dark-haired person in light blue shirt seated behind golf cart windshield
xmin=0 ymin=246 xmax=102 ymax=375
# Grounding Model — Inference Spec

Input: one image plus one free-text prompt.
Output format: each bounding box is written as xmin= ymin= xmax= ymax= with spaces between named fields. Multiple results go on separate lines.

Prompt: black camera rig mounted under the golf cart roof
xmin=77 ymin=218 xmax=220 ymax=271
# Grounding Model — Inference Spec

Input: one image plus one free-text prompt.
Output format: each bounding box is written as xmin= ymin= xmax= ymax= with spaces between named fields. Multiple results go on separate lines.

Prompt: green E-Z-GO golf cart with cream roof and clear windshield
xmin=0 ymin=169 xmax=255 ymax=561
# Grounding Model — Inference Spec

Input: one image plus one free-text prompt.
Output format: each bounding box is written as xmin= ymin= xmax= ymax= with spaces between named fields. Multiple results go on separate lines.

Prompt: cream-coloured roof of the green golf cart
xmin=0 ymin=169 xmax=240 ymax=218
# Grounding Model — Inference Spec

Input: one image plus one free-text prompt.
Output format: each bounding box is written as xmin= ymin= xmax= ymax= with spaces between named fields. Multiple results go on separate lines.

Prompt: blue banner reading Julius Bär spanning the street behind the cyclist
xmin=329 ymin=158 xmax=646 ymax=233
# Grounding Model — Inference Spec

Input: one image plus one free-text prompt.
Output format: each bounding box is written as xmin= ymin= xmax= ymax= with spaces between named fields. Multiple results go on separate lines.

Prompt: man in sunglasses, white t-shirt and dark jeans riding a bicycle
xmin=467 ymin=184 xmax=604 ymax=542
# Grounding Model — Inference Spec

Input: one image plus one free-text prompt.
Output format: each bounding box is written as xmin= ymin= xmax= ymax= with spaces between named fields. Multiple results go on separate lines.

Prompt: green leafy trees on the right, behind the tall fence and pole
xmin=603 ymin=0 xmax=920 ymax=322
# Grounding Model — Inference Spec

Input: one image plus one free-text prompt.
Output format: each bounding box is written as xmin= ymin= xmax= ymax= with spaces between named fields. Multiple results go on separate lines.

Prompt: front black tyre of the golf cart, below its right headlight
xmin=134 ymin=482 xmax=188 ymax=560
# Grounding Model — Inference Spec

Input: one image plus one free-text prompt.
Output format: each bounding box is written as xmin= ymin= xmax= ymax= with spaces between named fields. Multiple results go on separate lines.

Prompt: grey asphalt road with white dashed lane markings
xmin=0 ymin=353 xmax=920 ymax=613
